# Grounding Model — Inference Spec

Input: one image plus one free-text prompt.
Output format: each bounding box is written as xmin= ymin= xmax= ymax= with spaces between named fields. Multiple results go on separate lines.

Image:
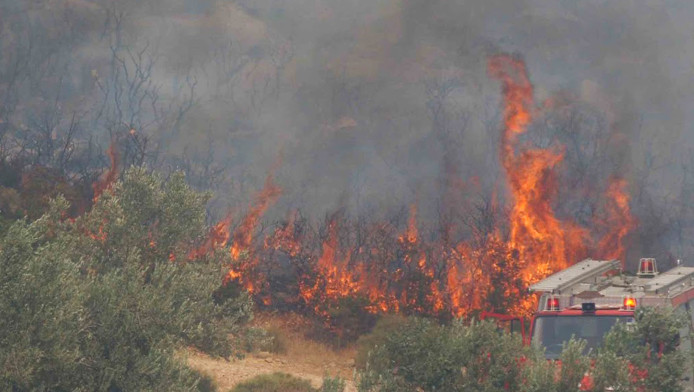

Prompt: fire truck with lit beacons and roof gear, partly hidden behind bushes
xmin=530 ymin=259 xmax=694 ymax=390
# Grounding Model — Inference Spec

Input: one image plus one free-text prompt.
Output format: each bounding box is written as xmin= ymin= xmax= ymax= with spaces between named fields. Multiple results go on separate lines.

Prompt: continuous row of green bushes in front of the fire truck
xmin=358 ymin=308 xmax=686 ymax=392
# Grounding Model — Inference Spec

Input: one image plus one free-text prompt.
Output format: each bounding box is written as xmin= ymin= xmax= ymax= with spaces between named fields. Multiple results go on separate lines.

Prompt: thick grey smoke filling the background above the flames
xmin=0 ymin=0 xmax=694 ymax=264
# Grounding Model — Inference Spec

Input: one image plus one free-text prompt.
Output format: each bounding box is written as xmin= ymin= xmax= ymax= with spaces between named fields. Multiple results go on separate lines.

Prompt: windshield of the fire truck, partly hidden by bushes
xmin=532 ymin=314 xmax=633 ymax=359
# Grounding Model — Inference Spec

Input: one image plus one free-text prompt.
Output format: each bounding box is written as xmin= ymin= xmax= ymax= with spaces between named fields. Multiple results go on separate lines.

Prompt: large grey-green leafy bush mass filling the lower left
xmin=0 ymin=169 xmax=250 ymax=392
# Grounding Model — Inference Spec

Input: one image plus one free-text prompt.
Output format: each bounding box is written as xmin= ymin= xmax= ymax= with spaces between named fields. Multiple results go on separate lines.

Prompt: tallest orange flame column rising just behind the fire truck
xmin=488 ymin=55 xmax=588 ymax=283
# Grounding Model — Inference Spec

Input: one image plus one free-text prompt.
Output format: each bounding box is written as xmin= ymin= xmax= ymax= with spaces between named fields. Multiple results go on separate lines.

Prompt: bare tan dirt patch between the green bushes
xmin=188 ymin=318 xmax=356 ymax=392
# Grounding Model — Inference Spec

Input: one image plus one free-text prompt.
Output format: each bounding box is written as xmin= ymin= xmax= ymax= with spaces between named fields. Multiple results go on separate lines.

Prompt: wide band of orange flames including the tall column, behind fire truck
xmin=191 ymin=55 xmax=636 ymax=322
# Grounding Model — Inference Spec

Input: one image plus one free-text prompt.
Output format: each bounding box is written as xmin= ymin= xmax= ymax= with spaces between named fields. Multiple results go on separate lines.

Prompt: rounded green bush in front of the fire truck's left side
xmin=359 ymin=319 xmax=528 ymax=392
